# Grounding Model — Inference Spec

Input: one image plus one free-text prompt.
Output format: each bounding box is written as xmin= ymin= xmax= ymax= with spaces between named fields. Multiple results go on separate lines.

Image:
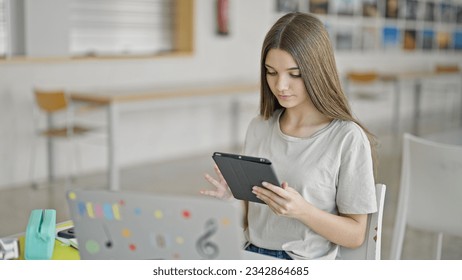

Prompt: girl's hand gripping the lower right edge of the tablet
xmin=252 ymin=182 xmax=310 ymax=218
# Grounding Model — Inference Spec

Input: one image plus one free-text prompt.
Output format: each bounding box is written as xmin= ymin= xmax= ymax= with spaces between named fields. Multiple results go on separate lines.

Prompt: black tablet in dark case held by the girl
xmin=212 ymin=152 xmax=281 ymax=203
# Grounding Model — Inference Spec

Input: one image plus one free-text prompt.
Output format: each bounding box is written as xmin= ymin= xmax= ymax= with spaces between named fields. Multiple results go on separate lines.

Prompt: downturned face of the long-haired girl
xmin=265 ymin=49 xmax=311 ymax=109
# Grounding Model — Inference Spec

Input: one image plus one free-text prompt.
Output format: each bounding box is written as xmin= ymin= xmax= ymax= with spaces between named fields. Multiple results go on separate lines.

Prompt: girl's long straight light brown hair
xmin=260 ymin=12 xmax=377 ymax=173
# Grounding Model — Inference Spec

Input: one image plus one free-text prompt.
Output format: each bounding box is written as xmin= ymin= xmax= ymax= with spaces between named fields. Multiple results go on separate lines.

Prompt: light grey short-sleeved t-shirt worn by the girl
xmin=244 ymin=110 xmax=377 ymax=259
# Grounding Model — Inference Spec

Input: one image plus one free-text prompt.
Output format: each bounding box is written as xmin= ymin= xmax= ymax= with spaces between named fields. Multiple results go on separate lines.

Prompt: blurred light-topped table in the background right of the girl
xmin=379 ymin=71 xmax=462 ymax=135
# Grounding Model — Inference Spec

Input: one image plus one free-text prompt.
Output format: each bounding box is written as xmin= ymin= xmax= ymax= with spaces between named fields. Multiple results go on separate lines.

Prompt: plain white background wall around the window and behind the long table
xmin=0 ymin=0 xmax=461 ymax=188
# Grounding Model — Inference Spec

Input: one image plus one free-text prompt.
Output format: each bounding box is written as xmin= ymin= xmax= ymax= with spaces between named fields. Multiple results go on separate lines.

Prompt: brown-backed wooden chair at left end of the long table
xmin=30 ymin=89 xmax=91 ymax=188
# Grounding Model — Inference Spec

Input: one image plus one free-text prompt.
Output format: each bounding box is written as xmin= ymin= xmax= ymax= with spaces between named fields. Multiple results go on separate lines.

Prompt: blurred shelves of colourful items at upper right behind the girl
xmin=275 ymin=0 xmax=462 ymax=54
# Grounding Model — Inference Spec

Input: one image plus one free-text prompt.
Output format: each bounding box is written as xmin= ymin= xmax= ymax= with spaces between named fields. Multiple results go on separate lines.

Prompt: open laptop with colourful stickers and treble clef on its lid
xmin=67 ymin=189 xmax=245 ymax=260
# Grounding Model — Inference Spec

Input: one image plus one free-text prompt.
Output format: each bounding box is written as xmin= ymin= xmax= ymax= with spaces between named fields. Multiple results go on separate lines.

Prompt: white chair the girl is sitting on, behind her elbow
xmin=339 ymin=184 xmax=386 ymax=260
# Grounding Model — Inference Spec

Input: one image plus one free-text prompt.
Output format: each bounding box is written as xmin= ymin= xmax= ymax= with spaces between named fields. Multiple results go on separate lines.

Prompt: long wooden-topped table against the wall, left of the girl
xmin=66 ymin=82 xmax=259 ymax=191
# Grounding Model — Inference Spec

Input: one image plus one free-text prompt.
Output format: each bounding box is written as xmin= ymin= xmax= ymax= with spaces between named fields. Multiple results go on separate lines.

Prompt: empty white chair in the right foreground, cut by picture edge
xmin=390 ymin=133 xmax=462 ymax=259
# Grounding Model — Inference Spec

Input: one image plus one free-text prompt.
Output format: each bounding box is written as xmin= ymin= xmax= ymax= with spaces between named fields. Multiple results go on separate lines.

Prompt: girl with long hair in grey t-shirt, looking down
xmin=202 ymin=13 xmax=377 ymax=259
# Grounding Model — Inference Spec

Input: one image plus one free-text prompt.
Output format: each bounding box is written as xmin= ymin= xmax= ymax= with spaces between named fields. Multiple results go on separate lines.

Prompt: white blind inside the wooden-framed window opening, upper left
xmin=69 ymin=0 xmax=175 ymax=56
